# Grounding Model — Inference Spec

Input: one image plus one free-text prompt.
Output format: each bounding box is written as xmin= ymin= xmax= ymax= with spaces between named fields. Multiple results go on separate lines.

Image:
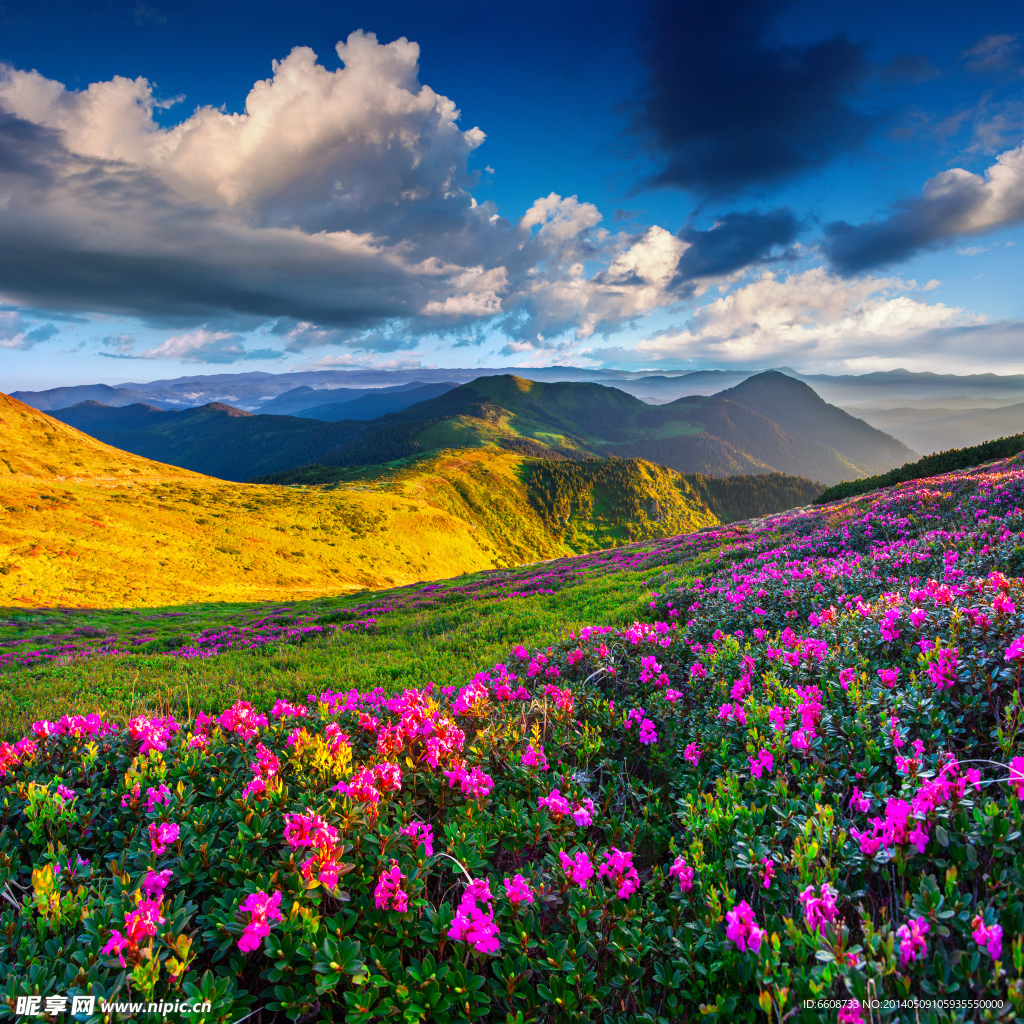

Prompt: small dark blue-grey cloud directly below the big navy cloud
xmin=674 ymin=209 xmax=800 ymax=284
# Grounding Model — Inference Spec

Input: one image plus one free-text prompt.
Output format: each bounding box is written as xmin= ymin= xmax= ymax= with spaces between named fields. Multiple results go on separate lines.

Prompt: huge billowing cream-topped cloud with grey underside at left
xmin=0 ymin=32 xmax=741 ymax=361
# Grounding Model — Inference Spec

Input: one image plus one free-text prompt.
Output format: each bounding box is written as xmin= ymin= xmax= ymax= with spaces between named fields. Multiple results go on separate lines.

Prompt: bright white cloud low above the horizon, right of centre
xmin=593 ymin=267 xmax=984 ymax=367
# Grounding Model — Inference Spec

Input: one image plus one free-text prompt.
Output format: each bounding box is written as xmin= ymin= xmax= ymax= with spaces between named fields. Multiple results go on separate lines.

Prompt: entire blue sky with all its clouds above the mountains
xmin=0 ymin=0 xmax=1024 ymax=391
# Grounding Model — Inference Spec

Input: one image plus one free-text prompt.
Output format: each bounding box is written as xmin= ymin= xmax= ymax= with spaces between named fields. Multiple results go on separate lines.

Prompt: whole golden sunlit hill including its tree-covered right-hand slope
xmin=0 ymin=394 xmax=820 ymax=607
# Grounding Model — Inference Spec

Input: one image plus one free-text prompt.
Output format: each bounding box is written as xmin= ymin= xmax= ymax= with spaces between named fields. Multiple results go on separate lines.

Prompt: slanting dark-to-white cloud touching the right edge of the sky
xmin=823 ymin=144 xmax=1024 ymax=274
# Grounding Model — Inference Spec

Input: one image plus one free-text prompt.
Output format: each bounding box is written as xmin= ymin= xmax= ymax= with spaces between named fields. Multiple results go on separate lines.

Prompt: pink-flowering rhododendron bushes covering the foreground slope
xmin=6 ymin=461 xmax=1024 ymax=1024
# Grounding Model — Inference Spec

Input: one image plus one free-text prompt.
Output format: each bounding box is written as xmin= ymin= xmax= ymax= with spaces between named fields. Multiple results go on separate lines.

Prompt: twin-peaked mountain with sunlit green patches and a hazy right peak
xmin=326 ymin=371 xmax=914 ymax=483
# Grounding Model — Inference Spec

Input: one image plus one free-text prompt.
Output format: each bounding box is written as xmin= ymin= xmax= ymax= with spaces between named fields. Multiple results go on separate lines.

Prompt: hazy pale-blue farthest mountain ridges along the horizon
xmin=13 ymin=367 xmax=1024 ymax=453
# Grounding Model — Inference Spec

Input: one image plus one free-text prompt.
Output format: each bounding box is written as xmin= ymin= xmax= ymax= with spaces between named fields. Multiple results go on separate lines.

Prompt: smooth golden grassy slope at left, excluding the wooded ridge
xmin=0 ymin=395 xmax=552 ymax=606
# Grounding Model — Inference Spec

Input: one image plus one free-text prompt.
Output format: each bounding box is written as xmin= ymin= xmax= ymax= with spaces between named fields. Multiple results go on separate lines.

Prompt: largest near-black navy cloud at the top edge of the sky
xmin=635 ymin=0 xmax=874 ymax=196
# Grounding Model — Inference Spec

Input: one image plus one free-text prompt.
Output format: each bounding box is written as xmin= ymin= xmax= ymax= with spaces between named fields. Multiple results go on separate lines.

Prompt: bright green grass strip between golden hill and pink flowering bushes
xmin=0 ymin=566 xmax=679 ymax=739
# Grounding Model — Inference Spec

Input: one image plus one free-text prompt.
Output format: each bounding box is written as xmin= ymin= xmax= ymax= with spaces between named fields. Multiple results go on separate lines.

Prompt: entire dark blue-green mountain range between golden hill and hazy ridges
xmin=44 ymin=371 xmax=915 ymax=484
